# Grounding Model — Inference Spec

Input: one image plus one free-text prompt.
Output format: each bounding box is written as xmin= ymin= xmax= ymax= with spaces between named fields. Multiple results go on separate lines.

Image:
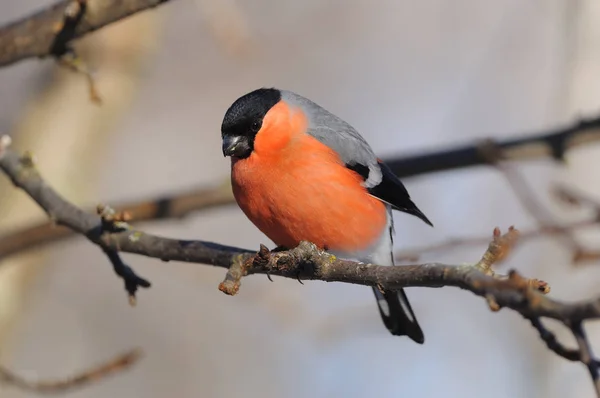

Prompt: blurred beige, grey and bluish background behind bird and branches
xmin=0 ymin=0 xmax=600 ymax=398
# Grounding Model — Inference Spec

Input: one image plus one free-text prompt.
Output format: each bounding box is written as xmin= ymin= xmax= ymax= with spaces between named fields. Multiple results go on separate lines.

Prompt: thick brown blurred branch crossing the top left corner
xmin=0 ymin=0 xmax=173 ymax=67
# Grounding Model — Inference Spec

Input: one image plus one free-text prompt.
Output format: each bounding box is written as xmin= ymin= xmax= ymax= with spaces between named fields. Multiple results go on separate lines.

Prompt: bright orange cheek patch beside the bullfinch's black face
xmin=254 ymin=101 xmax=308 ymax=155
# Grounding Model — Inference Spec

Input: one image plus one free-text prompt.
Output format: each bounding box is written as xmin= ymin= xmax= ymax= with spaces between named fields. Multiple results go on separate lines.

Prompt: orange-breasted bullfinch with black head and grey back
xmin=221 ymin=87 xmax=433 ymax=344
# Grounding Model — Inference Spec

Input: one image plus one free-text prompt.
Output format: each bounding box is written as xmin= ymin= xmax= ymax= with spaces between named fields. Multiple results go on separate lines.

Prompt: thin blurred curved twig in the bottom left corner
xmin=0 ymin=350 xmax=141 ymax=394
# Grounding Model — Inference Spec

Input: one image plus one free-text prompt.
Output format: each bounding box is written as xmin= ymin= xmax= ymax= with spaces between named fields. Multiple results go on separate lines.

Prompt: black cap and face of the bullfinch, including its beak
xmin=221 ymin=88 xmax=281 ymax=159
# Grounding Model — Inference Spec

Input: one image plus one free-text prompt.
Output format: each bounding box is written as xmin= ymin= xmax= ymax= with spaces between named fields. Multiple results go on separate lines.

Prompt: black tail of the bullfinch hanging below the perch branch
xmin=373 ymin=287 xmax=425 ymax=344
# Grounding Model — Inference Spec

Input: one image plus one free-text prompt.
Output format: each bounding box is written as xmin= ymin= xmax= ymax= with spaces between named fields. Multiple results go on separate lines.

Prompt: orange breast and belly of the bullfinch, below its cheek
xmin=231 ymin=133 xmax=386 ymax=252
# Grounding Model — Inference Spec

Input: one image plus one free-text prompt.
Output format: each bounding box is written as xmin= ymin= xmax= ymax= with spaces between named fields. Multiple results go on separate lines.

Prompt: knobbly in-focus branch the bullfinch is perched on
xmin=0 ymin=136 xmax=600 ymax=394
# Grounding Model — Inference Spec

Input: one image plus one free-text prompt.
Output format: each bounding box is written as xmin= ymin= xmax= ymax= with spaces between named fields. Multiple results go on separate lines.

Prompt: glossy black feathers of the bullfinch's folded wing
xmin=346 ymin=160 xmax=433 ymax=227
